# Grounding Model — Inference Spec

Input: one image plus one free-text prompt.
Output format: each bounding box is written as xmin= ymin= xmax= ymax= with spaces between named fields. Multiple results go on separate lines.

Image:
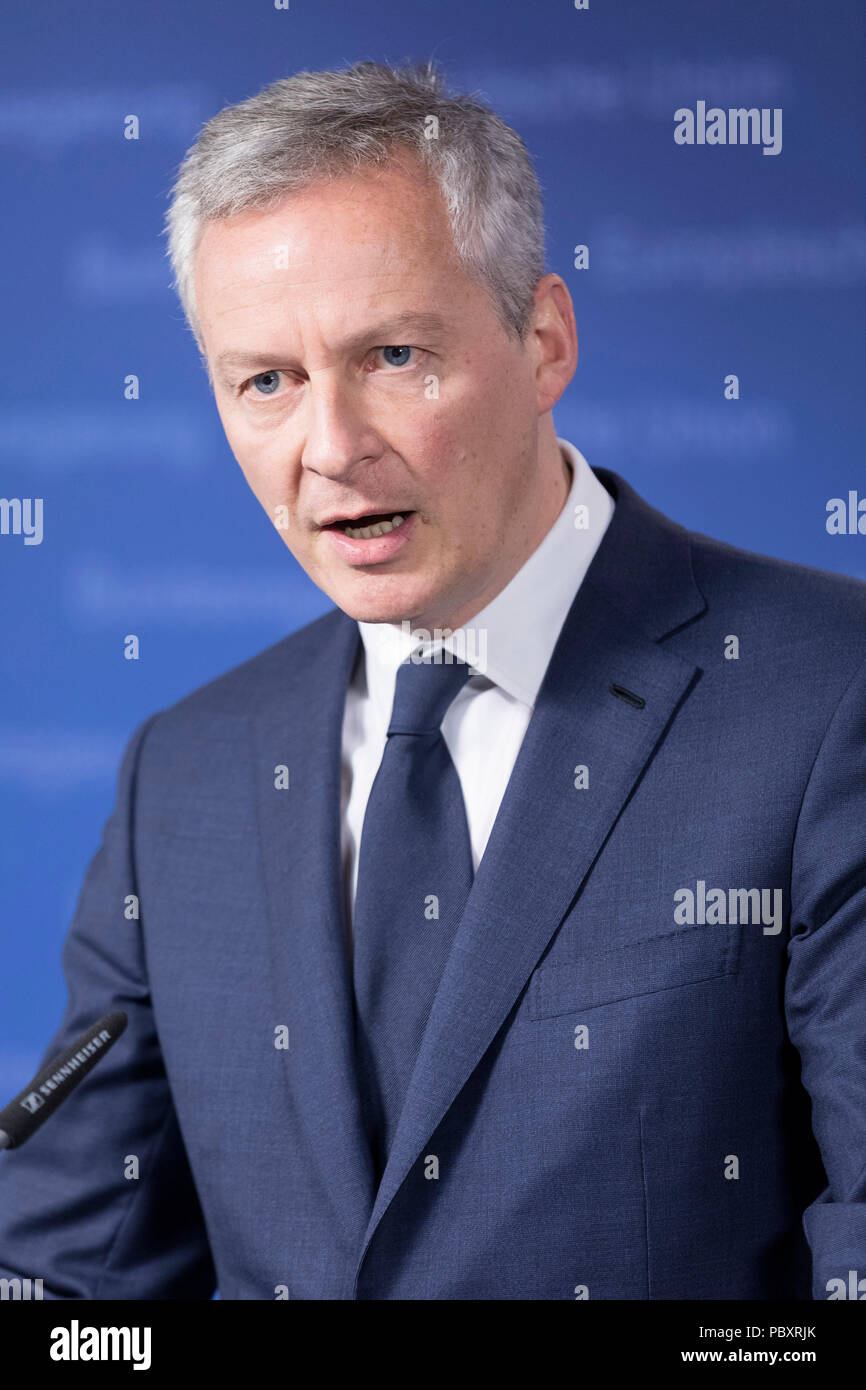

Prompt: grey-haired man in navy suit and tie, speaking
xmin=0 ymin=64 xmax=866 ymax=1300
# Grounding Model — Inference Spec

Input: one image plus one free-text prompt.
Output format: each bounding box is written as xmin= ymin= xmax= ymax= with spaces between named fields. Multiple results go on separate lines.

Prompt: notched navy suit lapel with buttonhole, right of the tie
xmin=356 ymin=470 xmax=706 ymax=1286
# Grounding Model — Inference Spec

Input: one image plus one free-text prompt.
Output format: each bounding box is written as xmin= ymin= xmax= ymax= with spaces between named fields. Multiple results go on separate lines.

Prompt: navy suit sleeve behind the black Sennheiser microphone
xmin=0 ymin=714 xmax=215 ymax=1300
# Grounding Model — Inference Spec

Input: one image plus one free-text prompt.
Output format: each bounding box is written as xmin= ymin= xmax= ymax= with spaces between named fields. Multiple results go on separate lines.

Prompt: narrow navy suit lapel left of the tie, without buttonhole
xmin=253 ymin=610 xmax=375 ymax=1250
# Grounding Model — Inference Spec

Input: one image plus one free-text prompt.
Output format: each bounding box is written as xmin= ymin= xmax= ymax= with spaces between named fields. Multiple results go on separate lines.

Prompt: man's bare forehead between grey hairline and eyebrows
xmin=195 ymin=158 xmax=468 ymax=344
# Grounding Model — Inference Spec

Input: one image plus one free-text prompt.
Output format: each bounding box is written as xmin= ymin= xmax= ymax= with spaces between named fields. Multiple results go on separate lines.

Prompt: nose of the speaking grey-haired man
xmin=300 ymin=368 xmax=384 ymax=482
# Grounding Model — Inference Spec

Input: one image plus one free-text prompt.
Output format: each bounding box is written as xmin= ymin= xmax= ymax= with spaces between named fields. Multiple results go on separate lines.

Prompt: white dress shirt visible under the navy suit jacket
xmin=341 ymin=439 xmax=613 ymax=922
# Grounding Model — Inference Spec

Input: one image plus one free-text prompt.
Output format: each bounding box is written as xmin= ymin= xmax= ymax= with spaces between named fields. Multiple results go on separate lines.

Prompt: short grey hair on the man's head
xmin=165 ymin=63 xmax=545 ymax=349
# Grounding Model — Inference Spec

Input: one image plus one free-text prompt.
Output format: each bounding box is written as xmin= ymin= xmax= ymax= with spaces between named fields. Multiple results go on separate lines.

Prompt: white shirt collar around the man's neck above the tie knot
xmin=359 ymin=439 xmax=613 ymax=720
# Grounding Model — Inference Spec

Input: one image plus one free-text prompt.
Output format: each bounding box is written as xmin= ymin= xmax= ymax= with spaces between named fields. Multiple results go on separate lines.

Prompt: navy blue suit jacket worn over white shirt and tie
xmin=0 ymin=470 xmax=866 ymax=1300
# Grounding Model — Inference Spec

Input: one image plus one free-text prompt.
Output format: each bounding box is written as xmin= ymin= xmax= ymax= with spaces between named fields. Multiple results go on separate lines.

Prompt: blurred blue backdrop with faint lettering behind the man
xmin=0 ymin=0 xmax=866 ymax=1104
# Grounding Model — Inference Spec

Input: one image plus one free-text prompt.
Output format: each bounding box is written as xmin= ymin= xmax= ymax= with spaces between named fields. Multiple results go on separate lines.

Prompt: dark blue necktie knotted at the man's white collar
xmin=352 ymin=653 xmax=473 ymax=1177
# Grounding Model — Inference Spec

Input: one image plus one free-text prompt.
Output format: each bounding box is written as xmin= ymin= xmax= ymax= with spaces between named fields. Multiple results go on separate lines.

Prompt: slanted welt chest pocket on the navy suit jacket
xmin=528 ymin=924 xmax=742 ymax=1019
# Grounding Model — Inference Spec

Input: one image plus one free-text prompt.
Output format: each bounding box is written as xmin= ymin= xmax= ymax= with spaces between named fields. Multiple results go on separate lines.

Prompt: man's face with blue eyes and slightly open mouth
xmin=195 ymin=156 xmax=561 ymax=628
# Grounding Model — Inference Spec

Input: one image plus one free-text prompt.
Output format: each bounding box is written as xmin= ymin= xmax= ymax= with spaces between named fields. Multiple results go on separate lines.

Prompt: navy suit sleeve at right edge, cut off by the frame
xmin=785 ymin=666 xmax=866 ymax=1298
